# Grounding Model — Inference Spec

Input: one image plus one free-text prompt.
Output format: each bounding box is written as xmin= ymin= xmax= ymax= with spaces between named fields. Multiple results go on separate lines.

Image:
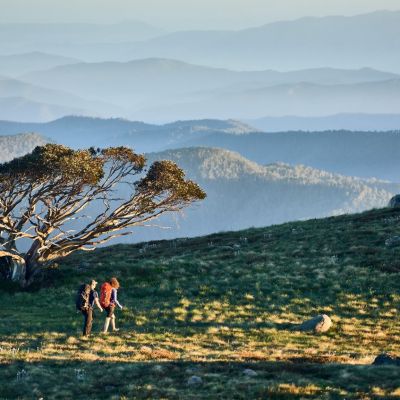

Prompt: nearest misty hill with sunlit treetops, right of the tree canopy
xmin=135 ymin=148 xmax=400 ymax=240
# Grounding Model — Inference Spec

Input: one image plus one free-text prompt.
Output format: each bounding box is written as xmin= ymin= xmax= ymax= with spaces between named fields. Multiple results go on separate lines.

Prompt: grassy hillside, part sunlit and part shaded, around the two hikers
xmin=0 ymin=209 xmax=400 ymax=399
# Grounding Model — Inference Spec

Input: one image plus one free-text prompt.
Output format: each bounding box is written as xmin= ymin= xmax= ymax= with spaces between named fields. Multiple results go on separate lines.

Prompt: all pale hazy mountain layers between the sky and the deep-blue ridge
xmin=0 ymin=12 xmax=400 ymax=123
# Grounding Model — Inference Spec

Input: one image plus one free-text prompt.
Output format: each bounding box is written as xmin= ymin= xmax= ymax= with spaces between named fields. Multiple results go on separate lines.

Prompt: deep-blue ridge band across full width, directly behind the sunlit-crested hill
xmin=0 ymin=117 xmax=400 ymax=182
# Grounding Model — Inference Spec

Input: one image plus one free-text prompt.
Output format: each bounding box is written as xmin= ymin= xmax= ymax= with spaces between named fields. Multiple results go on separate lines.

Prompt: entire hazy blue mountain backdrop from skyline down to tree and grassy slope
xmin=0 ymin=5 xmax=400 ymax=240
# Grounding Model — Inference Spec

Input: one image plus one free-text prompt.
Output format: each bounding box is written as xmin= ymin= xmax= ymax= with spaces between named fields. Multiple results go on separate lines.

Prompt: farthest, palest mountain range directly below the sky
xmin=0 ymin=11 xmax=400 ymax=72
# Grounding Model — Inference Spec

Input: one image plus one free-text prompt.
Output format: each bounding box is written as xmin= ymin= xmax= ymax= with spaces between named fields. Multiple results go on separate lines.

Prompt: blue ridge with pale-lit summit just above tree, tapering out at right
xmin=0 ymin=116 xmax=256 ymax=152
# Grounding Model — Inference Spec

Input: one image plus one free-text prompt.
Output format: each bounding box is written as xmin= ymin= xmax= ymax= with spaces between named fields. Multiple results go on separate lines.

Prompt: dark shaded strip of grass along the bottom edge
xmin=0 ymin=360 xmax=400 ymax=399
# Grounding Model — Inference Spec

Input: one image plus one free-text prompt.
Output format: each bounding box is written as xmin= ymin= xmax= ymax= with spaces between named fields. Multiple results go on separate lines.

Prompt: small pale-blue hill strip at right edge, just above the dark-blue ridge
xmin=246 ymin=113 xmax=400 ymax=132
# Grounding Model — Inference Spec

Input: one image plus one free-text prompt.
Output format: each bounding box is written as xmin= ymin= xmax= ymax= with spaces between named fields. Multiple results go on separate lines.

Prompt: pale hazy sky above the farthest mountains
xmin=0 ymin=0 xmax=400 ymax=30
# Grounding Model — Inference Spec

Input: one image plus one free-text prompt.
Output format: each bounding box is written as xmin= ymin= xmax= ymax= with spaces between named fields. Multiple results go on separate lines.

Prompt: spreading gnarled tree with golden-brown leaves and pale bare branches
xmin=0 ymin=144 xmax=206 ymax=284
